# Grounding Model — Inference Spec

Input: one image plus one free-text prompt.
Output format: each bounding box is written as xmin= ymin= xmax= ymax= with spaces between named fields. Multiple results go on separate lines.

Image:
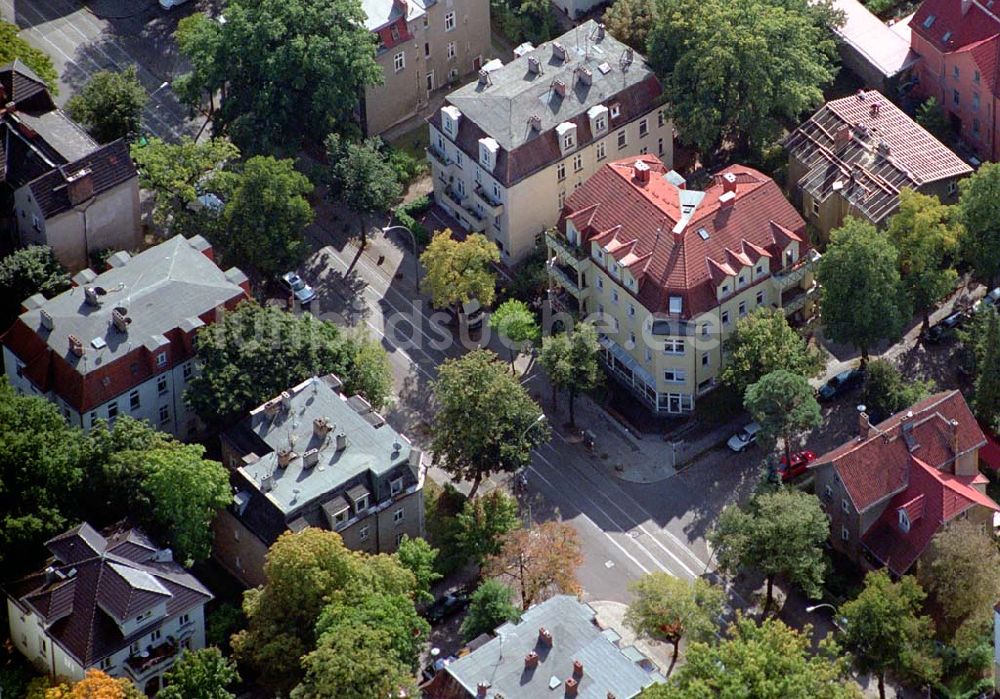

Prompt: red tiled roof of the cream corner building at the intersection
xmin=559 ymin=155 xmax=809 ymax=318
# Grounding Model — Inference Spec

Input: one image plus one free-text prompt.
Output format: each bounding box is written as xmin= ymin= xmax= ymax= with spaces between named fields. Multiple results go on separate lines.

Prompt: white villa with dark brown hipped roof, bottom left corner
xmin=6 ymin=523 xmax=212 ymax=696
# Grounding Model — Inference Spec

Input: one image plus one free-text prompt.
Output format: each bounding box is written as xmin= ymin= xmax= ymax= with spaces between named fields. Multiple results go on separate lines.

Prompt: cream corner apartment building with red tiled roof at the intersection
xmin=546 ymin=156 xmax=819 ymax=414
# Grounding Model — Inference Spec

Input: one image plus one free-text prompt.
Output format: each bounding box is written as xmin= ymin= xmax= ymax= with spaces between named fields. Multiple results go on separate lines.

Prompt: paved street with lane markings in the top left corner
xmin=0 ymin=0 xmax=201 ymax=140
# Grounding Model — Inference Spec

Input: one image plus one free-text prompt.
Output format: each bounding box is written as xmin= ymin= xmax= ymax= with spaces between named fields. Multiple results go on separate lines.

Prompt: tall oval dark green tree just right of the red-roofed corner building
xmin=818 ymin=218 xmax=910 ymax=367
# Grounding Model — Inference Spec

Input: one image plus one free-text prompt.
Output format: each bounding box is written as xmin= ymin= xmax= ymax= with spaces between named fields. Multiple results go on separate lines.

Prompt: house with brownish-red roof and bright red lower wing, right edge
xmin=810 ymin=391 xmax=1000 ymax=575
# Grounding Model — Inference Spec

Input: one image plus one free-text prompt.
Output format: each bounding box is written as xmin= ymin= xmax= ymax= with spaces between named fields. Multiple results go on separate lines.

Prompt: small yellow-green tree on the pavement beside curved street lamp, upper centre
xmin=420 ymin=229 xmax=500 ymax=308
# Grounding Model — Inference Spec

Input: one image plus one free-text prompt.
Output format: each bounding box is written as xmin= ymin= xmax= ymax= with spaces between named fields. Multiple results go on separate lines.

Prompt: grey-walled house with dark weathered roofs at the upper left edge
xmin=0 ymin=61 xmax=142 ymax=271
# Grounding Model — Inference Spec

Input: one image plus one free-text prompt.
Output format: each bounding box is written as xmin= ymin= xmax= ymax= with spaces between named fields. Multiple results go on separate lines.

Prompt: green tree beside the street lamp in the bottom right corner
xmin=840 ymin=570 xmax=941 ymax=699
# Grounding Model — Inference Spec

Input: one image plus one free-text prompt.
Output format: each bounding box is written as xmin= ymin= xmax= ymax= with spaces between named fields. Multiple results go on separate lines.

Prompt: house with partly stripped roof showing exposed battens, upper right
xmin=785 ymin=90 xmax=972 ymax=239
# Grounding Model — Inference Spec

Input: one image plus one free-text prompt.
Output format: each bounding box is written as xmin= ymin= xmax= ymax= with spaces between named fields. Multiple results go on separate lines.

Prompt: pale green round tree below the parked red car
xmin=709 ymin=489 xmax=830 ymax=609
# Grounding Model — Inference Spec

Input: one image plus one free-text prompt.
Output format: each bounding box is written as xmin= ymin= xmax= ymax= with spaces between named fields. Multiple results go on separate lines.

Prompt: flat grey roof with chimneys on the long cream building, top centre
xmin=447 ymin=20 xmax=653 ymax=151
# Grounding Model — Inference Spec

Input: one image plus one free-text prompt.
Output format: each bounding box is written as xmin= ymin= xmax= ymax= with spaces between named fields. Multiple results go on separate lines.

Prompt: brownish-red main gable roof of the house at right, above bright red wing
xmin=812 ymin=391 xmax=986 ymax=512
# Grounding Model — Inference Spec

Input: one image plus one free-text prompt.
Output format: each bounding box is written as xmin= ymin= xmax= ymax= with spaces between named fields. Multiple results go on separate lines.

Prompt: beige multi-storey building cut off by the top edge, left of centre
xmin=361 ymin=0 xmax=492 ymax=135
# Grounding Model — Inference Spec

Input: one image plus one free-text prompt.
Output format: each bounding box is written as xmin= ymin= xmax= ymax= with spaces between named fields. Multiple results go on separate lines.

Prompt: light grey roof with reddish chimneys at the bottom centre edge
xmin=445 ymin=595 xmax=664 ymax=699
